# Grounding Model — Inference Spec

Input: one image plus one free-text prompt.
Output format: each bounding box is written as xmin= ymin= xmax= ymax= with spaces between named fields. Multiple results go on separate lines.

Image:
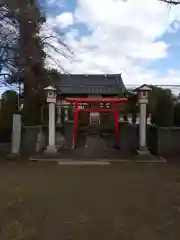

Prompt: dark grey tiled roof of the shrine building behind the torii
xmin=57 ymin=74 xmax=125 ymax=95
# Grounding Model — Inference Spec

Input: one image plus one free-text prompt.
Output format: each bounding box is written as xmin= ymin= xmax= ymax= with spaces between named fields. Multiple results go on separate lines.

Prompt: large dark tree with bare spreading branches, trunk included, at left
xmin=1 ymin=0 xmax=71 ymax=124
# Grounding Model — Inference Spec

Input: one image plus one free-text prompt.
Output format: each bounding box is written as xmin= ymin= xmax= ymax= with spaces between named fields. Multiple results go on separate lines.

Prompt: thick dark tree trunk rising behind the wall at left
xmin=19 ymin=0 xmax=44 ymax=125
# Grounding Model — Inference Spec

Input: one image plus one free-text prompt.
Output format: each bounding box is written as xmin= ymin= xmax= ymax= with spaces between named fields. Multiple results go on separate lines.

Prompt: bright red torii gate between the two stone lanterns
xmin=65 ymin=97 xmax=128 ymax=149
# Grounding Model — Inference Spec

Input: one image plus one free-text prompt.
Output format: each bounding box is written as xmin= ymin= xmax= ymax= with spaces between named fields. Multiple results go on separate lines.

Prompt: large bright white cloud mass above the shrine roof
xmin=44 ymin=0 xmax=180 ymax=87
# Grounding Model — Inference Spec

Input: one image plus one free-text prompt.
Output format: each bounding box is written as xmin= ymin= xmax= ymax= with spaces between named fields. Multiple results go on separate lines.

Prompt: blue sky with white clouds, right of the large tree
xmin=41 ymin=0 xmax=180 ymax=84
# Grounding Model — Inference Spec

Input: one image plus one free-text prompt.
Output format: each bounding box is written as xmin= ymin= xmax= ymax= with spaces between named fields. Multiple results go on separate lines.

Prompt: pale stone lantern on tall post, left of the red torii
xmin=44 ymin=86 xmax=57 ymax=153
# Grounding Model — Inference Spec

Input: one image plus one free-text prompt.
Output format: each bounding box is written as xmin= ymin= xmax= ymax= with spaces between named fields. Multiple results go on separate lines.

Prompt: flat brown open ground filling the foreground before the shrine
xmin=0 ymin=163 xmax=180 ymax=240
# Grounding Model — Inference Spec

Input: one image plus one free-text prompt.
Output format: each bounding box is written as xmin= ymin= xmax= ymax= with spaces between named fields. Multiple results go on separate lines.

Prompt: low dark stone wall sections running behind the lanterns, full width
xmin=14 ymin=121 xmax=180 ymax=157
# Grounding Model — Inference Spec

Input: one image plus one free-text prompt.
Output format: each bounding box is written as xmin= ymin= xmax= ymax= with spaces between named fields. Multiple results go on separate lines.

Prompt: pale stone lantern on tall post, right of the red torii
xmin=135 ymin=84 xmax=152 ymax=154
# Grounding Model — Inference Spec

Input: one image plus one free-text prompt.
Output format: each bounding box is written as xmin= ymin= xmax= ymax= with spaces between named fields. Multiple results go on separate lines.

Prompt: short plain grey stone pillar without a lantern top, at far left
xmin=11 ymin=114 xmax=21 ymax=154
